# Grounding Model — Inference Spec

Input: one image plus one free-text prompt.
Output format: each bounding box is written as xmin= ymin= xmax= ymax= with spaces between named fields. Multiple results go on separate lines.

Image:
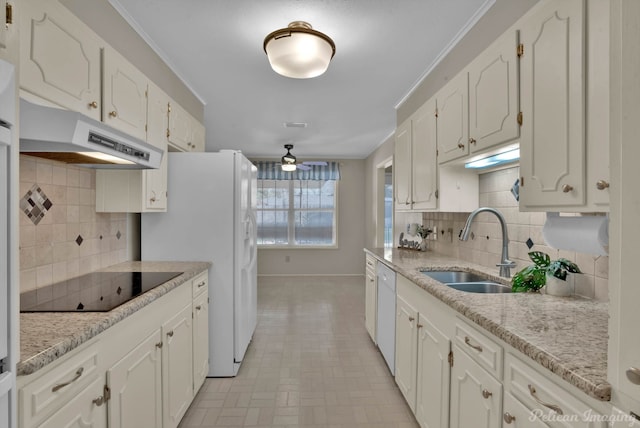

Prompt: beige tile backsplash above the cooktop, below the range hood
xmin=20 ymin=155 xmax=128 ymax=292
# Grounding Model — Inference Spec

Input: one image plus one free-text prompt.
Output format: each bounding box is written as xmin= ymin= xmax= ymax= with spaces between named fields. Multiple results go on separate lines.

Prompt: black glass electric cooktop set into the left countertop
xmin=20 ymin=272 xmax=183 ymax=312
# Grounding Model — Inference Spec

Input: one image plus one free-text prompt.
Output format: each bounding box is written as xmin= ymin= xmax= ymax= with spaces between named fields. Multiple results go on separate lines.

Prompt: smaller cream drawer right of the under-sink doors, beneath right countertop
xmin=455 ymin=319 xmax=503 ymax=379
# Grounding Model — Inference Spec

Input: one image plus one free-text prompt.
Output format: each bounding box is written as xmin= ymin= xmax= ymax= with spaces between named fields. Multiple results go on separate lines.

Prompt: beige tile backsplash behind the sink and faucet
xmin=422 ymin=167 xmax=609 ymax=301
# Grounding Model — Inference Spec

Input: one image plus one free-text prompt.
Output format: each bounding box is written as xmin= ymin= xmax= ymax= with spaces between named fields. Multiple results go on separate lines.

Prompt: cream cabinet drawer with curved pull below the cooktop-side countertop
xmin=19 ymin=343 xmax=99 ymax=427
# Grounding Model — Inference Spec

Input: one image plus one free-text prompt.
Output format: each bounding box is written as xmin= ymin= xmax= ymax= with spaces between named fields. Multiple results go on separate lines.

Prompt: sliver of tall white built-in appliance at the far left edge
xmin=0 ymin=60 xmax=17 ymax=427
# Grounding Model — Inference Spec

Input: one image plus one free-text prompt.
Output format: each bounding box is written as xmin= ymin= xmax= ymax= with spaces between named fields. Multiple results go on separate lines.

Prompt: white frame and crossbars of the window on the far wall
xmin=256 ymin=179 xmax=340 ymax=250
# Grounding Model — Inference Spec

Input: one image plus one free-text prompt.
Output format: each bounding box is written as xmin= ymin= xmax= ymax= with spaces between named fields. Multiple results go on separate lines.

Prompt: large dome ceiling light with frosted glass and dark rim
xmin=263 ymin=21 xmax=336 ymax=79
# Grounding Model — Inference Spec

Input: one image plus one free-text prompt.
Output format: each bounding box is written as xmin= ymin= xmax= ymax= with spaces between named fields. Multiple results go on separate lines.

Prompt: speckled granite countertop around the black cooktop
xmin=17 ymin=262 xmax=211 ymax=376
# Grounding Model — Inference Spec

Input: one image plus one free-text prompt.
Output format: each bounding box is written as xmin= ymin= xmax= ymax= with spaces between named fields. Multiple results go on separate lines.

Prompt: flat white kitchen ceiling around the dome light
xmin=110 ymin=0 xmax=493 ymax=159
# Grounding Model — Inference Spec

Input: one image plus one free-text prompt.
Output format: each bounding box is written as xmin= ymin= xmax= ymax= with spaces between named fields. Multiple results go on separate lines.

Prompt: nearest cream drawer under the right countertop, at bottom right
xmin=504 ymin=354 xmax=604 ymax=428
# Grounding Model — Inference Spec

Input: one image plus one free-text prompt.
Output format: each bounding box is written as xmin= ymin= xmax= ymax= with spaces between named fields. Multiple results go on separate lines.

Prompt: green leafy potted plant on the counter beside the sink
xmin=511 ymin=251 xmax=582 ymax=296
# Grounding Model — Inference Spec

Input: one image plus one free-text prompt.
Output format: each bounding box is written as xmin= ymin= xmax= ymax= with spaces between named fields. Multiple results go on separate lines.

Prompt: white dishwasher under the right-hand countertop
xmin=376 ymin=263 xmax=396 ymax=375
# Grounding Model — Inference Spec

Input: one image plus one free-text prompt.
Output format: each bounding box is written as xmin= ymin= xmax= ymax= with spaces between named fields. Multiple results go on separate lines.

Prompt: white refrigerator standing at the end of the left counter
xmin=141 ymin=150 xmax=257 ymax=377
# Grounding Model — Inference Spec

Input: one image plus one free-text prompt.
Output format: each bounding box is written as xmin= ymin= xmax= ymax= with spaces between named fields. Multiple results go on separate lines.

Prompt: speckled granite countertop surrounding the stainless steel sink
xmin=365 ymin=248 xmax=611 ymax=401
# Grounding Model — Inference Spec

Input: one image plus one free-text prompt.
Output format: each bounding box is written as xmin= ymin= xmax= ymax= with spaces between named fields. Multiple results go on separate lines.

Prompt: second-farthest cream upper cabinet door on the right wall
xmin=411 ymin=98 xmax=438 ymax=209
